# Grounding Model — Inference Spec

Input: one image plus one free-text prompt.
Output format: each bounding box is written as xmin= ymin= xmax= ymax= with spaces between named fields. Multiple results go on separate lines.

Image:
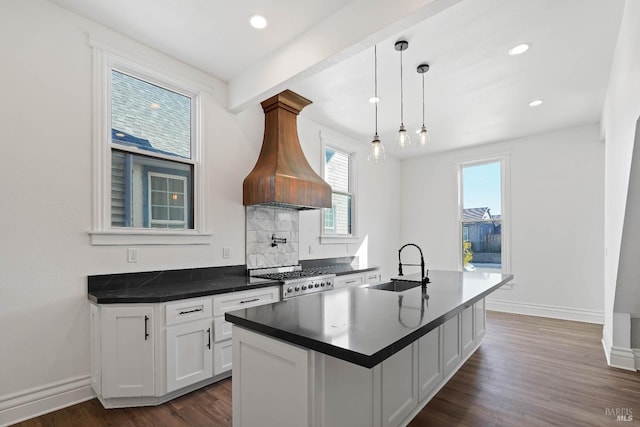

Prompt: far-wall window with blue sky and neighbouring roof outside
xmin=458 ymin=156 xmax=508 ymax=272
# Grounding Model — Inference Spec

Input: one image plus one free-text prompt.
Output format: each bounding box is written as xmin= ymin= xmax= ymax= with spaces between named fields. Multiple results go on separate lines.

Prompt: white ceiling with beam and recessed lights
xmin=50 ymin=0 xmax=624 ymax=158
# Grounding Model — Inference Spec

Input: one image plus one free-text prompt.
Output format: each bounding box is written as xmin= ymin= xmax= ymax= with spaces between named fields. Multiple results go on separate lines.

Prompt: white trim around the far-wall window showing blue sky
xmin=455 ymin=153 xmax=511 ymax=274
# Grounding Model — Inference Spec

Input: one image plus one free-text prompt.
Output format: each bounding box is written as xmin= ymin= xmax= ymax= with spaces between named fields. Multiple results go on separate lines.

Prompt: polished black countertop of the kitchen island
xmin=225 ymin=270 xmax=513 ymax=368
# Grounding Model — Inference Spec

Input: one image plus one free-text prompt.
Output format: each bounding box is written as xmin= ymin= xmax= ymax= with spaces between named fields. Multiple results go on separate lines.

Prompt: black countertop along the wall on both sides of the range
xmin=88 ymin=259 xmax=377 ymax=304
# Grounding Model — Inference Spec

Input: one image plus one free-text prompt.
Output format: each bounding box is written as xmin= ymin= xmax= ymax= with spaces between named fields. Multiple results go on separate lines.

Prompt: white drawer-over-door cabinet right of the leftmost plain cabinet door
xmin=166 ymin=298 xmax=213 ymax=392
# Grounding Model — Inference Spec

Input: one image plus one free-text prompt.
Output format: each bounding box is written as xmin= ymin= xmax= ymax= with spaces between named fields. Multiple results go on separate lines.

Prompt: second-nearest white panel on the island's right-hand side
xmin=418 ymin=325 xmax=444 ymax=401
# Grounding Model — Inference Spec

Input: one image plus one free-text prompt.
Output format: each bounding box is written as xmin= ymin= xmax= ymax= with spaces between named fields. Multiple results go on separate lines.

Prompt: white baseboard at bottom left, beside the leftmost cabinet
xmin=0 ymin=376 xmax=96 ymax=426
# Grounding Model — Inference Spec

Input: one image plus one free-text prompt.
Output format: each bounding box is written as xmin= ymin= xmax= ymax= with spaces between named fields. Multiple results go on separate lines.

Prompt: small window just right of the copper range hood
xmin=322 ymin=146 xmax=355 ymax=237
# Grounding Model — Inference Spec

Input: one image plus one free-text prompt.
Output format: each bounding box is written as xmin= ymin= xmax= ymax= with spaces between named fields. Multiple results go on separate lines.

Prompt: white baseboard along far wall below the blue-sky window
xmin=486 ymin=298 xmax=604 ymax=325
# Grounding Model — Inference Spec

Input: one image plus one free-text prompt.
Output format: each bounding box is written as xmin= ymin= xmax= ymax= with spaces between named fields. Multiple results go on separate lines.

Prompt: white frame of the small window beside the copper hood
xmin=320 ymin=142 xmax=359 ymax=244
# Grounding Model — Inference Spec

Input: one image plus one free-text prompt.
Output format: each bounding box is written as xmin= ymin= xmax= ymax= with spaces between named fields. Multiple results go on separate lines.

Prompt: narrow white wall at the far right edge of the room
xmin=602 ymin=1 xmax=640 ymax=359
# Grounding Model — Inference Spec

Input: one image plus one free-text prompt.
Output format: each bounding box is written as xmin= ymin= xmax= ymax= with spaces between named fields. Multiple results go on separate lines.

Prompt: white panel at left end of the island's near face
xmin=232 ymin=326 xmax=312 ymax=427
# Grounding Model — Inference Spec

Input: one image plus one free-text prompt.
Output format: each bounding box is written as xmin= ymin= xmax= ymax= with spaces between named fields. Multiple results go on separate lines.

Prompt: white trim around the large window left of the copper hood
xmin=89 ymin=35 xmax=212 ymax=245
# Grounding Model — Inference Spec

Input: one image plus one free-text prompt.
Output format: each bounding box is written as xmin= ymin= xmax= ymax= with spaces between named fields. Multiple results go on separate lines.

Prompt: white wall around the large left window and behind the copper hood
xmin=0 ymin=0 xmax=399 ymax=425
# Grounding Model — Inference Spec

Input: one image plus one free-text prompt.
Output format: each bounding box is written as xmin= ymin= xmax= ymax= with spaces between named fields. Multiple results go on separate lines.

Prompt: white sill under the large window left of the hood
xmin=89 ymin=229 xmax=213 ymax=246
